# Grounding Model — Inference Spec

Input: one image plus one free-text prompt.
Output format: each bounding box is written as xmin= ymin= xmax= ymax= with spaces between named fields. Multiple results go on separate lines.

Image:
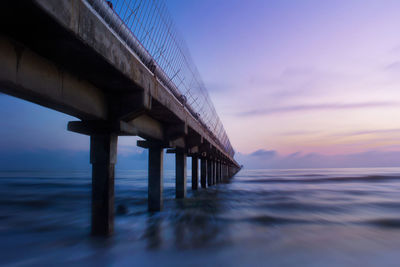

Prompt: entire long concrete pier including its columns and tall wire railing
xmin=0 ymin=0 xmax=240 ymax=235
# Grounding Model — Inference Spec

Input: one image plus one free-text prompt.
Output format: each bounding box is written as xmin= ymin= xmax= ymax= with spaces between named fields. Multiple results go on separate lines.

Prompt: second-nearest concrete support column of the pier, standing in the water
xmin=148 ymin=145 xmax=164 ymax=211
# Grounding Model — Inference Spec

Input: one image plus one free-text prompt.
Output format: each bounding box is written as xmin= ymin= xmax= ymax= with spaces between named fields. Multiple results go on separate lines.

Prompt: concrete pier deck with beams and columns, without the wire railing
xmin=0 ymin=0 xmax=240 ymax=235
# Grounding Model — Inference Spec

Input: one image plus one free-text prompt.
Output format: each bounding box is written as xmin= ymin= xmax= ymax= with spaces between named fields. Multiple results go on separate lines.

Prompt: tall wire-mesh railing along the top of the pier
xmin=86 ymin=0 xmax=234 ymax=157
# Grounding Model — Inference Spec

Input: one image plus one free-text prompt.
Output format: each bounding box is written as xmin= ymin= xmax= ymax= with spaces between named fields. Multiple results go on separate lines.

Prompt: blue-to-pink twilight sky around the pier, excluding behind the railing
xmin=0 ymin=0 xmax=400 ymax=168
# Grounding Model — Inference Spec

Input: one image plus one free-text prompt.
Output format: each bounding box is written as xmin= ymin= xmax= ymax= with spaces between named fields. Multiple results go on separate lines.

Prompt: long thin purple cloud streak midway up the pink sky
xmin=236 ymin=102 xmax=399 ymax=117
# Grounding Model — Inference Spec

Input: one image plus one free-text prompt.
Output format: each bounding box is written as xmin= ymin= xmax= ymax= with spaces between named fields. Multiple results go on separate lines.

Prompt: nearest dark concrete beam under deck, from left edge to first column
xmin=0 ymin=34 xmax=108 ymax=120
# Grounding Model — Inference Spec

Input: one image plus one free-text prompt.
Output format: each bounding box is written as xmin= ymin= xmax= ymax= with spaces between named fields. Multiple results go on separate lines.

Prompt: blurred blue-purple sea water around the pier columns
xmin=0 ymin=168 xmax=400 ymax=266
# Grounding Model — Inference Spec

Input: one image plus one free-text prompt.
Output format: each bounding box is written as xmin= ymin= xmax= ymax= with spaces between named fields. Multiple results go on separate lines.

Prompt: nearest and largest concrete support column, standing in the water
xmin=90 ymin=134 xmax=118 ymax=236
